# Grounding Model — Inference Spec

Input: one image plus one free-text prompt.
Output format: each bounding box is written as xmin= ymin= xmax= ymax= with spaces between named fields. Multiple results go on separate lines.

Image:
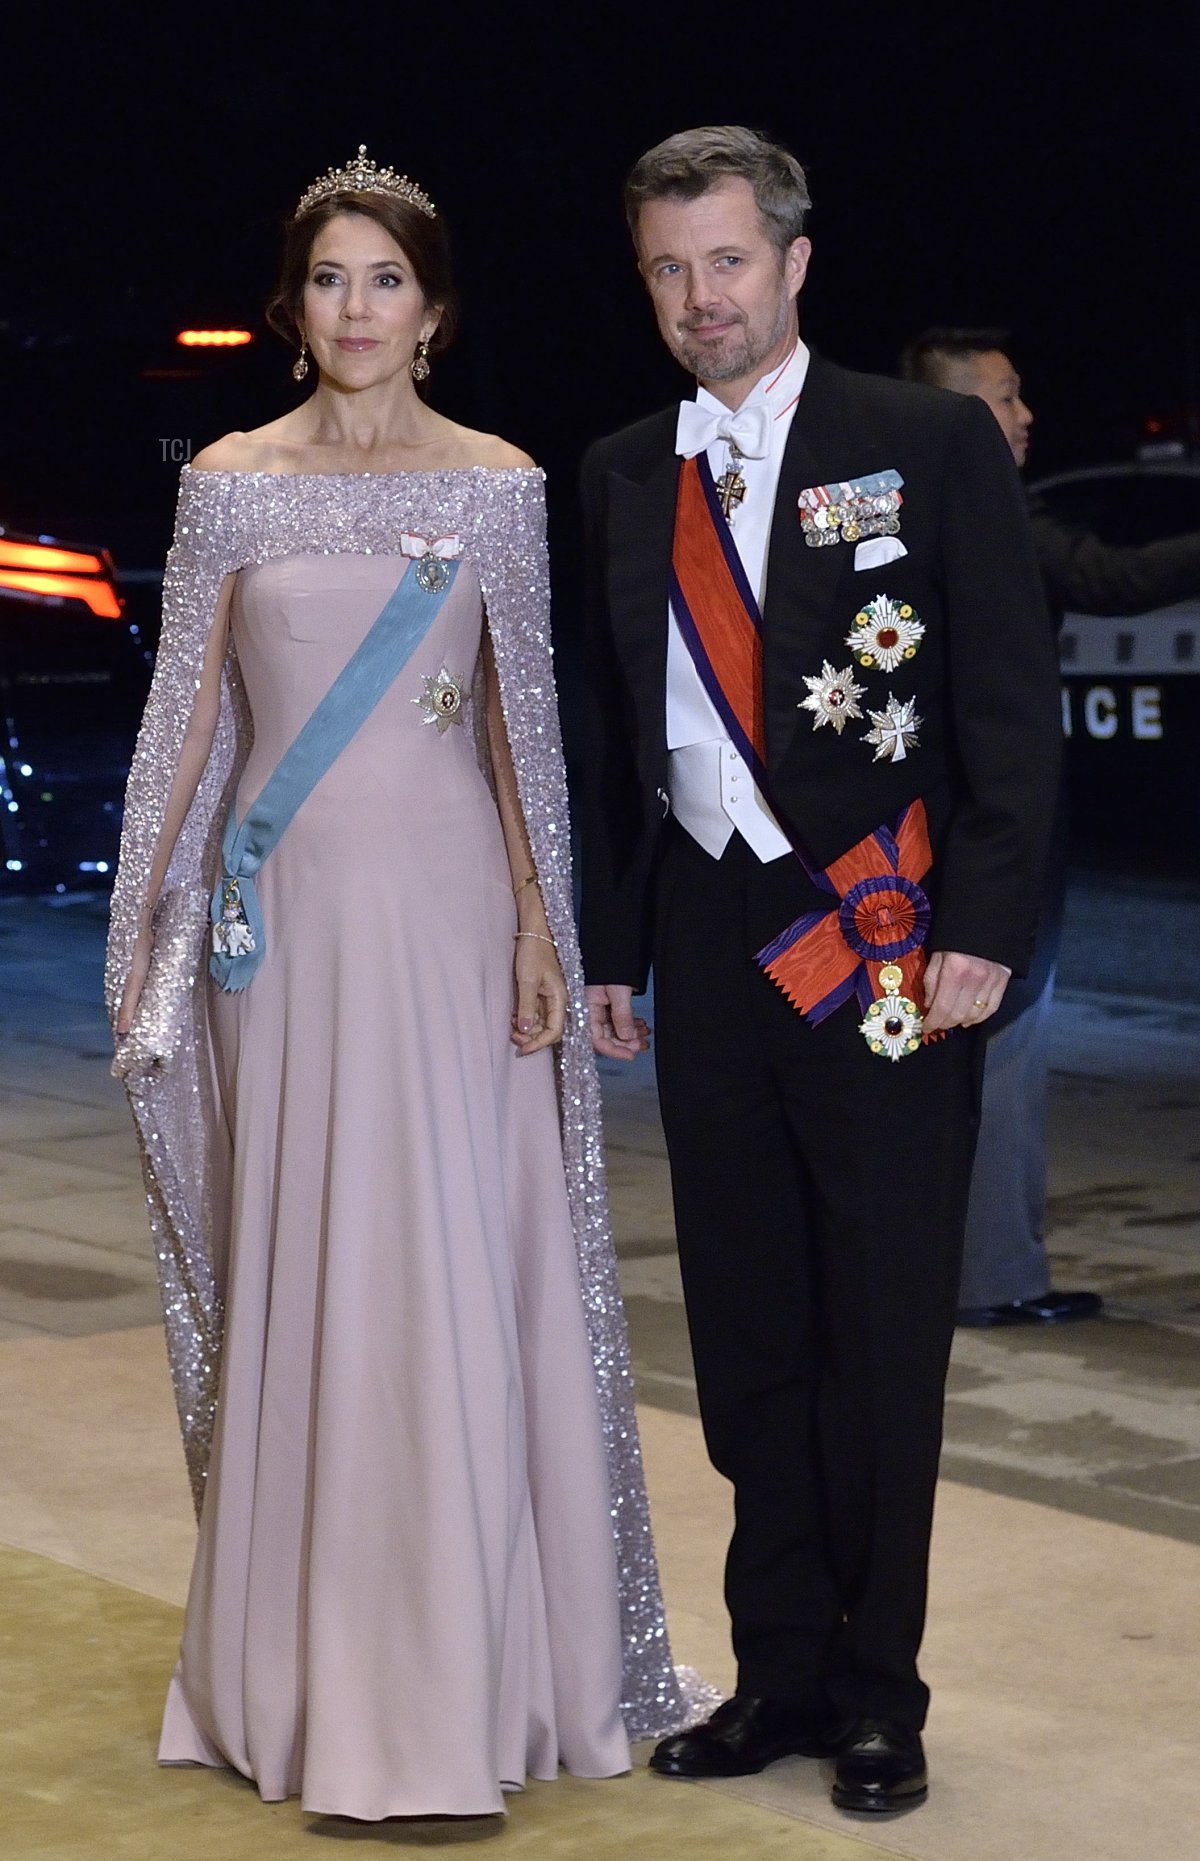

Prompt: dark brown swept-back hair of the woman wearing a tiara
xmin=266 ymin=190 xmax=458 ymax=355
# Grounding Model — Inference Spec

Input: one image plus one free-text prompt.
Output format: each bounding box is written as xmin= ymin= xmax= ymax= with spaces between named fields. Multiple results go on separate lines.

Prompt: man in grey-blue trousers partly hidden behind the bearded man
xmin=900 ymin=329 xmax=1200 ymax=1325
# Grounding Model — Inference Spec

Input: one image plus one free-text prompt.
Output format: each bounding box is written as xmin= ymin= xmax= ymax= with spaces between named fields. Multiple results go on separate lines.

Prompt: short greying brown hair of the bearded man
xmin=625 ymin=123 xmax=813 ymax=257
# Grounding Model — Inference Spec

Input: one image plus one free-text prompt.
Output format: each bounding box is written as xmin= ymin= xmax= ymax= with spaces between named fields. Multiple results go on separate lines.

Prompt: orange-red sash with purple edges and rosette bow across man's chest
xmin=670 ymin=452 xmax=932 ymax=1025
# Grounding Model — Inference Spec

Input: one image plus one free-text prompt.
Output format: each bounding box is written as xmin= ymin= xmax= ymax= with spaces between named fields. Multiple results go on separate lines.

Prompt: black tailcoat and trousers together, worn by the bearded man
xmin=580 ymin=355 xmax=1059 ymax=1727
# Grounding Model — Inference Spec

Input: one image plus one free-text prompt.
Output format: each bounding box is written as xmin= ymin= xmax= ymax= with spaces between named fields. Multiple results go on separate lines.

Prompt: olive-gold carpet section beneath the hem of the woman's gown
xmin=0 ymin=1548 xmax=882 ymax=1861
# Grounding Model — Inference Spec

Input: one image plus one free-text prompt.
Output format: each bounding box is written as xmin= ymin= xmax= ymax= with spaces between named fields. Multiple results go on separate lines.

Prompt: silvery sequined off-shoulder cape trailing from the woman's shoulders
xmin=104 ymin=467 xmax=696 ymax=1738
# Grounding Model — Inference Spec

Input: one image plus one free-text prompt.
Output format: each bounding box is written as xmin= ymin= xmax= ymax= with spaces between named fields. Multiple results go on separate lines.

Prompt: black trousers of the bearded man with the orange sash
xmin=655 ymin=824 xmax=982 ymax=1729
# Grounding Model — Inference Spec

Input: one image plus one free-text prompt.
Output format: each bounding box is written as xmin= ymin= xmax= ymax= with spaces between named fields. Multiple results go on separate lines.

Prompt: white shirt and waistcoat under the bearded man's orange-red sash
xmin=666 ymin=342 xmax=809 ymax=860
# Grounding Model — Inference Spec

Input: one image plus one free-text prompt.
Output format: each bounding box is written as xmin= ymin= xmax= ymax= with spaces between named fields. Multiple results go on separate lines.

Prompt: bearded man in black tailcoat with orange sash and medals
xmin=580 ymin=128 xmax=1059 ymax=1811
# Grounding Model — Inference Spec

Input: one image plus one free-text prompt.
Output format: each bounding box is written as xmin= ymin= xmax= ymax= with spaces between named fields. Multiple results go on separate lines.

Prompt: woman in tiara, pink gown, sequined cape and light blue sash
xmin=106 ymin=149 xmax=683 ymax=1820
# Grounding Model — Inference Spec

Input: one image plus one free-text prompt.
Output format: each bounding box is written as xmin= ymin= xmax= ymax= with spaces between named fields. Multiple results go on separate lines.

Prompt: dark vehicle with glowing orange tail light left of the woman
xmin=0 ymin=318 xmax=266 ymax=893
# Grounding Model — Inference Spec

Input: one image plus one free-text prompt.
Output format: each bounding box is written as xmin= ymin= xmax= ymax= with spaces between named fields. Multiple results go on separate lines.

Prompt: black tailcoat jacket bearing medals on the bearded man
xmin=580 ymin=355 xmax=1060 ymax=986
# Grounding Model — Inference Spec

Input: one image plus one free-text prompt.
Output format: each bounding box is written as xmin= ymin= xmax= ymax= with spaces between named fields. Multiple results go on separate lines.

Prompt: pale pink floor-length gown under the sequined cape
xmin=160 ymin=555 xmax=629 ymax=1820
